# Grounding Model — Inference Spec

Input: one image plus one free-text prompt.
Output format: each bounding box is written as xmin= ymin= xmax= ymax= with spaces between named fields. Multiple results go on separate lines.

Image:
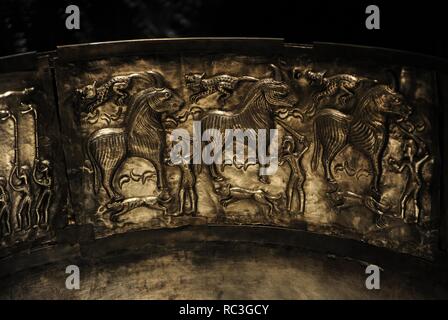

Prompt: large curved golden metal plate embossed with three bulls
xmin=52 ymin=40 xmax=438 ymax=256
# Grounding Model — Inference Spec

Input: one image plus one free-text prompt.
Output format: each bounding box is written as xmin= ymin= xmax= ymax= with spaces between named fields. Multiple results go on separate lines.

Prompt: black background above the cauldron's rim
xmin=0 ymin=0 xmax=448 ymax=58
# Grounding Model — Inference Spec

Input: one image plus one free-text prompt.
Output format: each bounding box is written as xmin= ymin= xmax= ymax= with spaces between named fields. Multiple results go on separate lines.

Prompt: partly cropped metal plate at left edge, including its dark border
xmin=0 ymin=54 xmax=67 ymax=254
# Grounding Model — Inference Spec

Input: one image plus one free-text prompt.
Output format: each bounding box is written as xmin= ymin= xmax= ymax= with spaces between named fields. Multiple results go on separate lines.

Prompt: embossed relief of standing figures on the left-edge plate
xmin=0 ymin=88 xmax=53 ymax=242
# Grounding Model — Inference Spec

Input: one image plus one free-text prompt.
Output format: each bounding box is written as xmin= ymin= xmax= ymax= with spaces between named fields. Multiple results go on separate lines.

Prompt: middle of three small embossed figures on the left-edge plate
xmin=9 ymin=165 xmax=32 ymax=230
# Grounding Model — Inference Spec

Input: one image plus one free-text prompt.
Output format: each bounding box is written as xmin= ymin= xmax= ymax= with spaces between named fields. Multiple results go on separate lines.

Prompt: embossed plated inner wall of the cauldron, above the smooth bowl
xmin=0 ymin=39 xmax=445 ymax=258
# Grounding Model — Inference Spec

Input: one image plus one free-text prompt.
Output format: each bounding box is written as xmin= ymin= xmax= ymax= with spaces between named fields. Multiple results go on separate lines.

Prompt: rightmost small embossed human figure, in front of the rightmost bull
xmin=389 ymin=139 xmax=429 ymax=223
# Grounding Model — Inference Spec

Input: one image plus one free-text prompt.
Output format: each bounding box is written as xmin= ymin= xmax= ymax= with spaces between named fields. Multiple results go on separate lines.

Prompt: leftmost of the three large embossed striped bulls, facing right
xmin=87 ymin=72 xmax=184 ymax=202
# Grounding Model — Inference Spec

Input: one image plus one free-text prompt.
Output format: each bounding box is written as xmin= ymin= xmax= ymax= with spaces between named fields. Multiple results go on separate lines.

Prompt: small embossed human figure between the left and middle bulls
xmin=167 ymin=157 xmax=198 ymax=216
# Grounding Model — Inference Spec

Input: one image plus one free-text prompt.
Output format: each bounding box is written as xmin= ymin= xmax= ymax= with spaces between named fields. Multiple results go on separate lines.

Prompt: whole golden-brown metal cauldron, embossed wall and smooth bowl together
xmin=0 ymin=38 xmax=448 ymax=299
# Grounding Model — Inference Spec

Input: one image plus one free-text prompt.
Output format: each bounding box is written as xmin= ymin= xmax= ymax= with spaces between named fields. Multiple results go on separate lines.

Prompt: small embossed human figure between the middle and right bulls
xmin=279 ymin=135 xmax=309 ymax=214
